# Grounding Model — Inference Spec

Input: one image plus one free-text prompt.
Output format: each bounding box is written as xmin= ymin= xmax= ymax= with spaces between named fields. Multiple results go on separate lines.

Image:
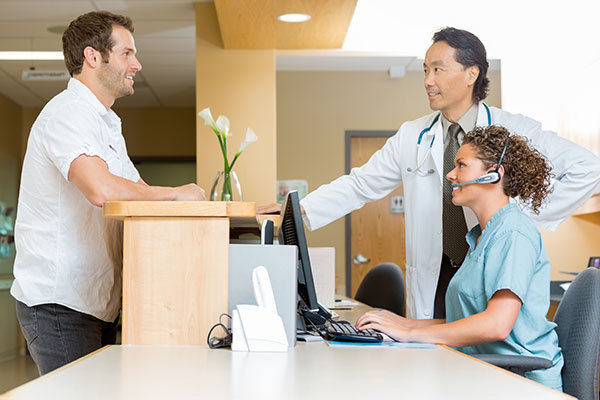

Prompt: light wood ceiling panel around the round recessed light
xmin=215 ymin=0 xmax=356 ymax=49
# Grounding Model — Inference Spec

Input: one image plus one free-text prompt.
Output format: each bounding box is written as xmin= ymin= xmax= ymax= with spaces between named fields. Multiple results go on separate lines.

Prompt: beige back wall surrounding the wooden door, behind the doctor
xmin=277 ymin=71 xmax=501 ymax=293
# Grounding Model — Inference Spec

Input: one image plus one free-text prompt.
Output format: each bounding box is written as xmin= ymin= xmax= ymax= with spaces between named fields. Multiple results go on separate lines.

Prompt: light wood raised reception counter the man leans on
xmin=104 ymin=201 xmax=256 ymax=345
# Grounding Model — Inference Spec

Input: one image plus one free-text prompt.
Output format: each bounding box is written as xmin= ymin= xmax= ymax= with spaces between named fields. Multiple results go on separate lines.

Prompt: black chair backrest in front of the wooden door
xmin=354 ymin=263 xmax=406 ymax=317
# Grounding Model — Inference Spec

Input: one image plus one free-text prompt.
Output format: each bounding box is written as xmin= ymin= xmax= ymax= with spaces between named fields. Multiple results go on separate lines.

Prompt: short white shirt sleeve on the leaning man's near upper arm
xmin=42 ymin=106 xmax=106 ymax=181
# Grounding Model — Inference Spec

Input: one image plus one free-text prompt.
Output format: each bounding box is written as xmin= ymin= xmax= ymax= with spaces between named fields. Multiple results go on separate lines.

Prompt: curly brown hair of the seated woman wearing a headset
xmin=463 ymin=125 xmax=552 ymax=214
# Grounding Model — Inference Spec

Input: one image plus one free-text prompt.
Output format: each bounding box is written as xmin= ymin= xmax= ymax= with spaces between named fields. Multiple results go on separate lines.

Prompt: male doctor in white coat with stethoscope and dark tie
xmin=259 ymin=28 xmax=600 ymax=318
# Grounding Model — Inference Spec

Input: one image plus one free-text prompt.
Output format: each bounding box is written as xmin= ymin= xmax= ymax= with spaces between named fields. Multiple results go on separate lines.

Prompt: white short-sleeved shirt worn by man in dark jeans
xmin=11 ymin=78 xmax=140 ymax=322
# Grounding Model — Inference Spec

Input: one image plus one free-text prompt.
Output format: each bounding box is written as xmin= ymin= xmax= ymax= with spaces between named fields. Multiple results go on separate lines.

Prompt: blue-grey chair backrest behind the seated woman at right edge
xmin=554 ymin=268 xmax=600 ymax=400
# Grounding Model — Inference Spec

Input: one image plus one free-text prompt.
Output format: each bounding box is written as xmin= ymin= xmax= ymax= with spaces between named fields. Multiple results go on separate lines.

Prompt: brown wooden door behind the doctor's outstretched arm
xmin=346 ymin=136 xmax=406 ymax=297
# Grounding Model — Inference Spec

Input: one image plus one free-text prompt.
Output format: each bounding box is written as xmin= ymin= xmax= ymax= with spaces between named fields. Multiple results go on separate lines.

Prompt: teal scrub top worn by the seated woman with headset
xmin=446 ymin=204 xmax=563 ymax=390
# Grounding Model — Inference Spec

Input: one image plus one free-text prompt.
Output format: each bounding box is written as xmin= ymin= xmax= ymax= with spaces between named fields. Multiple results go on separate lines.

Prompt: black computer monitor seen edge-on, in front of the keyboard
xmin=277 ymin=190 xmax=319 ymax=311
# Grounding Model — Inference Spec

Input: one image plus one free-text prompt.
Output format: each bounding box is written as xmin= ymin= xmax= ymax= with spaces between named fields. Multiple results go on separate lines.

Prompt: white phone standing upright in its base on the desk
xmin=231 ymin=265 xmax=288 ymax=352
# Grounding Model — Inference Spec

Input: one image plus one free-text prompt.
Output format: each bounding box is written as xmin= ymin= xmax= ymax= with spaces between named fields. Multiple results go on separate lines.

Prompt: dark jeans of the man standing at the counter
xmin=16 ymin=301 xmax=119 ymax=375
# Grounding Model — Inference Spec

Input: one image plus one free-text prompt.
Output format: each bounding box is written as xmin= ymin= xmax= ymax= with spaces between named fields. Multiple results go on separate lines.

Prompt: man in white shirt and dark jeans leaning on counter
xmin=11 ymin=12 xmax=205 ymax=374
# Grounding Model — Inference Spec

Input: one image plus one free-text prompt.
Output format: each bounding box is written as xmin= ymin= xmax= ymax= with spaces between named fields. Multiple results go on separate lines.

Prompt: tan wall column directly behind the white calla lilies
xmin=196 ymin=3 xmax=277 ymax=204
